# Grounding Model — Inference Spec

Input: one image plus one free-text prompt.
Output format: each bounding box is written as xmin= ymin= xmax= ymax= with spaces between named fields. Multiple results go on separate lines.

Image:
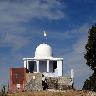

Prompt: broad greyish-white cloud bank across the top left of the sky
xmin=0 ymin=0 xmax=64 ymax=23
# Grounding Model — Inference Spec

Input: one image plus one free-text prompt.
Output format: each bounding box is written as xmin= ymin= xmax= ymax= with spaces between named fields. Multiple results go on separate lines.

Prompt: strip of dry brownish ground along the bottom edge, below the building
xmin=4 ymin=90 xmax=96 ymax=96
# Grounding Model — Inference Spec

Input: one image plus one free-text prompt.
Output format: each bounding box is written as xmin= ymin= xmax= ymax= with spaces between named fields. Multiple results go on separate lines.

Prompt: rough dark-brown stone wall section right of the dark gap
xmin=47 ymin=76 xmax=73 ymax=90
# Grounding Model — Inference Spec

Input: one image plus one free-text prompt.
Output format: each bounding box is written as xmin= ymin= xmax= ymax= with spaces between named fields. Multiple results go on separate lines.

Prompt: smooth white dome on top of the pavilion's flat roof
xmin=35 ymin=44 xmax=52 ymax=58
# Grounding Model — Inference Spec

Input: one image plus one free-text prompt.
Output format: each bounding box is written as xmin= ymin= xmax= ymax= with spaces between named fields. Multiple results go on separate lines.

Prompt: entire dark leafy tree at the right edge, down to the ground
xmin=83 ymin=25 xmax=96 ymax=91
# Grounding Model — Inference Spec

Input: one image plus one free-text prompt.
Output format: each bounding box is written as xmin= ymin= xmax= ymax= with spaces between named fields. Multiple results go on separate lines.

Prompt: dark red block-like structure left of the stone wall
xmin=8 ymin=68 xmax=26 ymax=92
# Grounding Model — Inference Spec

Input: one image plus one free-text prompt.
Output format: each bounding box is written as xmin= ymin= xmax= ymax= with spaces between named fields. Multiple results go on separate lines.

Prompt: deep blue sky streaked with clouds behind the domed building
xmin=0 ymin=0 xmax=96 ymax=89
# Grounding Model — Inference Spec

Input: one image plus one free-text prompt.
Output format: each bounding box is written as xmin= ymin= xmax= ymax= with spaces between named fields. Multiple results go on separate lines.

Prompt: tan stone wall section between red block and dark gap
xmin=25 ymin=73 xmax=43 ymax=91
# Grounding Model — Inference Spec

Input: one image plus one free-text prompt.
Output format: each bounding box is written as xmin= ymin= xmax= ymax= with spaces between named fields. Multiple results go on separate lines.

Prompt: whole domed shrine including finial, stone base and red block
xmin=8 ymin=32 xmax=74 ymax=92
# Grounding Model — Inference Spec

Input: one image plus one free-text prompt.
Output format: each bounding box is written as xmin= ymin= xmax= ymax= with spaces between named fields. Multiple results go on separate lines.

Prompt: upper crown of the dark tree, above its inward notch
xmin=84 ymin=25 xmax=96 ymax=72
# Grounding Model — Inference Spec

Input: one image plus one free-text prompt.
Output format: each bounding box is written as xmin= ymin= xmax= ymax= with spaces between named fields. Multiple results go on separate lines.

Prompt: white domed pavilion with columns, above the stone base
xmin=23 ymin=43 xmax=63 ymax=77
